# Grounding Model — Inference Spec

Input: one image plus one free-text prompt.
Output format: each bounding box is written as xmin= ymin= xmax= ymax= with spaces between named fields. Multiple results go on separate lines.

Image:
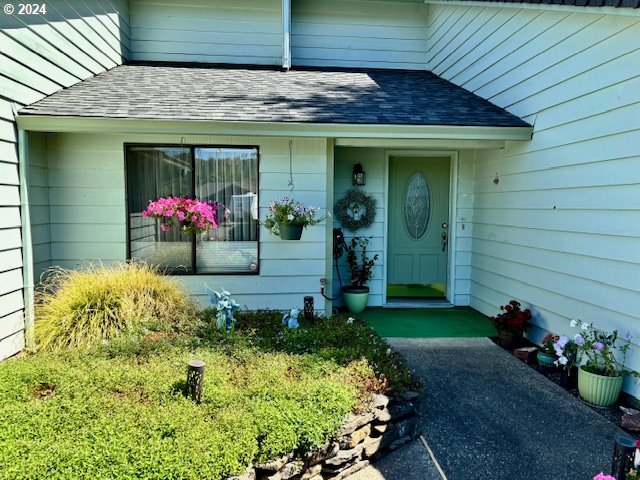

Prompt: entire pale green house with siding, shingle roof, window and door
xmin=0 ymin=0 xmax=640 ymax=393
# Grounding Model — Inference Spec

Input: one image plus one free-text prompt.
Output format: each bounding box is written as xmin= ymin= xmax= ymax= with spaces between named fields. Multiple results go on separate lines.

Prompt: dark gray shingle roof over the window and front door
xmin=19 ymin=64 xmax=529 ymax=127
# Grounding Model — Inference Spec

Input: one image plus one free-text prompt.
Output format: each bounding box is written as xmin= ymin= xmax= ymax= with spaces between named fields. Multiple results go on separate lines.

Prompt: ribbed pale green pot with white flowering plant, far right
xmin=571 ymin=320 xmax=632 ymax=407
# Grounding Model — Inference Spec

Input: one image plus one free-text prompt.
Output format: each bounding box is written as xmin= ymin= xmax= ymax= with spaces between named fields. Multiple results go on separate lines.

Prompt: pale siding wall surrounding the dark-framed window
xmin=39 ymin=134 xmax=327 ymax=310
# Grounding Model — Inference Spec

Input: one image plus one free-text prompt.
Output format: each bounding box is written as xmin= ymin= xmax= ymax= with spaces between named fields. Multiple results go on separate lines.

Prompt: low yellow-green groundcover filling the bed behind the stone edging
xmin=0 ymin=344 xmax=356 ymax=480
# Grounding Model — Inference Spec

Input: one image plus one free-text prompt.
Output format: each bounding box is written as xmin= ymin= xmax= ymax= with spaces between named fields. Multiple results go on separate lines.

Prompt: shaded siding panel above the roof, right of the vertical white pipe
xmin=291 ymin=0 xmax=428 ymax=70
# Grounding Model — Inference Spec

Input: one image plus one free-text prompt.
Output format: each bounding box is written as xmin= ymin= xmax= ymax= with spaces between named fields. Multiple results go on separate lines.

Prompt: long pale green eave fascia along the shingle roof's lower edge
xmin=16 ymin=114 xmax=533 ymax=141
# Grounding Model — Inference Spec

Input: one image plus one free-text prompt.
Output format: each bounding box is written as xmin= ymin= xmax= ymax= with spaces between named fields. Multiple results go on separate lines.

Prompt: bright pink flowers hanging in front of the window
xmin=142 ymin=195 xmax=218 ymax=234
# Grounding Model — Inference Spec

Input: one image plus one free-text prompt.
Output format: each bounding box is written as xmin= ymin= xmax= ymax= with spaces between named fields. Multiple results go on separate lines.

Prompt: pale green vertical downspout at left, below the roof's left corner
xmin=18 ymin=130 xmax=35 ymax=348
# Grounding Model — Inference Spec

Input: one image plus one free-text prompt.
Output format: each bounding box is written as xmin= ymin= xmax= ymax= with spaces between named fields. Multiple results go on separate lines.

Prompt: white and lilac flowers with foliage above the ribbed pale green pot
xmin=553 ymin=320 xmax=633 ymax=377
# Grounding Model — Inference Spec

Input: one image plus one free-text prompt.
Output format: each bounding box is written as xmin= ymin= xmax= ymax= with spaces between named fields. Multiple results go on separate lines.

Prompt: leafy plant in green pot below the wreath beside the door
xmin=342 ymin=237 xmax=378 ymax=313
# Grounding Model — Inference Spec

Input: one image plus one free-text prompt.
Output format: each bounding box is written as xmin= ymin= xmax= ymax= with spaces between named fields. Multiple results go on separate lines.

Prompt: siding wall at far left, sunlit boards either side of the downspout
xmin=0 ymin=0 xmax=129 ymax=359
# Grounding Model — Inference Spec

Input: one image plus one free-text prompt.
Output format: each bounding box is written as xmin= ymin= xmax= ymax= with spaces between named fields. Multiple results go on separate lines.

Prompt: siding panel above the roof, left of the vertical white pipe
xmin=131 ymin=0 xmax=282 ymax=65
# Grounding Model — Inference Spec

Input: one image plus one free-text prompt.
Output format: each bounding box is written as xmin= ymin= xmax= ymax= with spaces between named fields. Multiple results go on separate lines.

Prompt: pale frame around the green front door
xmin=382 ymin=150 xmax=458 ymax=305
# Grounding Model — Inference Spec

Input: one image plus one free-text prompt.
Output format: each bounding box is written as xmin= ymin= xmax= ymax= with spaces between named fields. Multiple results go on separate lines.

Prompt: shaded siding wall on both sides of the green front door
xmin=333 ymin=147 xmax=474 ymax=306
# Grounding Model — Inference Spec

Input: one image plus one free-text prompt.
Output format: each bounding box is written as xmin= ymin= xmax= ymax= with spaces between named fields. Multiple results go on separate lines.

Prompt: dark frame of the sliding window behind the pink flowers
xmin=122 ymin=142 xmax=262 ymax=276
